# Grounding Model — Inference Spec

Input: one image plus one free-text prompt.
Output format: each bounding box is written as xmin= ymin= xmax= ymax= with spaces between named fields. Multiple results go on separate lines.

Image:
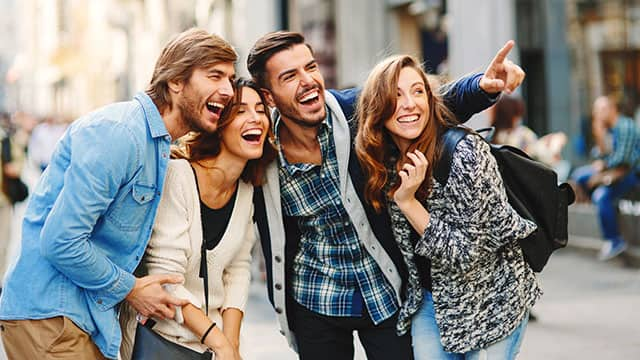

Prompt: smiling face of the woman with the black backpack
xmin=384 ymin=67 xmax=429 ymax=152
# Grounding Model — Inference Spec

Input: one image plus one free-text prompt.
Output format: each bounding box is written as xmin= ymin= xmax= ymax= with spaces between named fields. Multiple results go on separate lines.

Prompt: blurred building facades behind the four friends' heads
xmin=0 ymin=0 xmax=640 ymax=165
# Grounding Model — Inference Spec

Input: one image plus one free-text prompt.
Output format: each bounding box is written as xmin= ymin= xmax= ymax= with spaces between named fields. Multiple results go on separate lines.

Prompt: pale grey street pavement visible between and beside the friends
xmin=236 ymin=248 xmax=640 ymax=360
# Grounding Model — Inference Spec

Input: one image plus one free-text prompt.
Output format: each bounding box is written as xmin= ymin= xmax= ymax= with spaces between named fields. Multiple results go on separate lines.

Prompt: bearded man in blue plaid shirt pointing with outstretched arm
xmin=247 ymin=31 xmax=524 ymax=360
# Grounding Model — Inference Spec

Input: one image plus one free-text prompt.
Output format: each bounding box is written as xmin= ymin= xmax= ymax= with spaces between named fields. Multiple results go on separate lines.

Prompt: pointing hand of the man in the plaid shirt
xmin=480 ymin=40 xmax=525 ymax=94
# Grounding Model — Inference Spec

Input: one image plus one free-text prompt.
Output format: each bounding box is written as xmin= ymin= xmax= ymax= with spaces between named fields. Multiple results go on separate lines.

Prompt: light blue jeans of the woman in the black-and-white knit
xmin=411 ymin=290 xmax=529 ymax=360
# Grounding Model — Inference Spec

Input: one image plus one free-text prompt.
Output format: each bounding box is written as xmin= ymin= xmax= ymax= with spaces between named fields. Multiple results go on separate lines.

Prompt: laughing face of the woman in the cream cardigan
xmin=221 ymin=87 xmax=269 ymax=160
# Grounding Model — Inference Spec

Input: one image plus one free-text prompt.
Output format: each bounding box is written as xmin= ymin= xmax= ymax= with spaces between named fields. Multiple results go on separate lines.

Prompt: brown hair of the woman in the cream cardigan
xmin=171 ymin=78 xmax=276 ymax=186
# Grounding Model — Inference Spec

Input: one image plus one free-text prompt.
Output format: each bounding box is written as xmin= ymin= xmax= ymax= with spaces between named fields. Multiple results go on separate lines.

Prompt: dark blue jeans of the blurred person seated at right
xmin=572 ymin=165 xmax=640 ymax=241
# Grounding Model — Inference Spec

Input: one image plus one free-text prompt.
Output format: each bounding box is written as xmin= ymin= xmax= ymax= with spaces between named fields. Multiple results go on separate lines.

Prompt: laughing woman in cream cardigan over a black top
xmin=120 ymin=79 xmax=275 ymax=359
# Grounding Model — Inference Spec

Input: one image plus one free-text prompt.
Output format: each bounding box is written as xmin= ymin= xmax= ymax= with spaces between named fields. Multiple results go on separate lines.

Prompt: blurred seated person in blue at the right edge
xmin=572 ymin=96 xmax=640 ymax=260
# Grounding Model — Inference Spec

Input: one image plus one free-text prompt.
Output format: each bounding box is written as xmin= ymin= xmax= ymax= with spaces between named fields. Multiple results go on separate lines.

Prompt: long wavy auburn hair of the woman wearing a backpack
xmin=355 ymin=55 xmax=458 ymax=212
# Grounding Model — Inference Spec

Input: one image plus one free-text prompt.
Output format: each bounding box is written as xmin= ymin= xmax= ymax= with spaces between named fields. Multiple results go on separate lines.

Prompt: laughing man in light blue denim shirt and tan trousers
xmin=0 ymin=29 xmax=237 ymax=359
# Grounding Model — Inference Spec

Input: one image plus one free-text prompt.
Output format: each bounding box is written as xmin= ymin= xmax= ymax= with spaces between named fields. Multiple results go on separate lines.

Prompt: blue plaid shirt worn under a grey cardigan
xmin=275 ymin=111 xmax=398 ymax=324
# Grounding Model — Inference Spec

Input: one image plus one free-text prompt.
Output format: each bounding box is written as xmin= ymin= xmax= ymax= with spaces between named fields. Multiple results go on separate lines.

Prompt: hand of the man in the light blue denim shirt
xmin=126 ymin=274 xmax=189 ymax=319
